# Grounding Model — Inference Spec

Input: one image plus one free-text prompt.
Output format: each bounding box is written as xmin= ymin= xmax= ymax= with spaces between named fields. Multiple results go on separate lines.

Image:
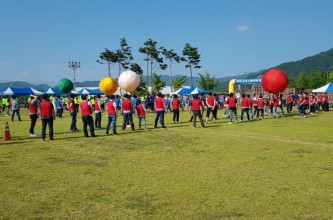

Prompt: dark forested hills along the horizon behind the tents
xmin=0 ymin=48 xmax=333 ymax=91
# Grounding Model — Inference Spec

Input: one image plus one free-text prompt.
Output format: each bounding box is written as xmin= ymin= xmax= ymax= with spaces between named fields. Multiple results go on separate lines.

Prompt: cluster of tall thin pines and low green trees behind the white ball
xmin=97 ymin=38 xmax=218 ymax=94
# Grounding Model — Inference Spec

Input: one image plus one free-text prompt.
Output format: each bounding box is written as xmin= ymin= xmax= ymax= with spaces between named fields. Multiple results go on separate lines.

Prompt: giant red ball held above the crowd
xmin=261 ymin=69 xmax=288 ymax=94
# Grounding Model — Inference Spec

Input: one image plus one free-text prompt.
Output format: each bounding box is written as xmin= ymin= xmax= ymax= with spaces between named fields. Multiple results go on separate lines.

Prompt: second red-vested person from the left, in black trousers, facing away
xmin=39 ymin=94 xmax=55 ymax=141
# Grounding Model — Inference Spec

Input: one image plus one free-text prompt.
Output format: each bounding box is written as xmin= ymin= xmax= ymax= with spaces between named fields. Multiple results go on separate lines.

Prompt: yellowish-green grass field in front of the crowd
xmin=0 ymin=107 xmax=333 ymax=219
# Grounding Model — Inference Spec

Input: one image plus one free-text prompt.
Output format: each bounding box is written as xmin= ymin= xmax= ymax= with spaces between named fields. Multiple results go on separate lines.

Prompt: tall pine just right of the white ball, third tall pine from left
xmin=139 ymin=39 xmax=167 ymax=91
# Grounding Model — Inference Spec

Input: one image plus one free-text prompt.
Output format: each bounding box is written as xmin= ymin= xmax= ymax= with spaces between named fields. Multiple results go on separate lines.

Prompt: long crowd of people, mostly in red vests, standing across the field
xmin=0 ymin=92 xmax=329 ymax=140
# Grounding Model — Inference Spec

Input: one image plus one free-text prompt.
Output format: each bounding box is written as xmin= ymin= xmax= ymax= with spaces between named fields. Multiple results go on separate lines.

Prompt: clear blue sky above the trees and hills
xmin=0 ymin=0 xmax=333 ymax=82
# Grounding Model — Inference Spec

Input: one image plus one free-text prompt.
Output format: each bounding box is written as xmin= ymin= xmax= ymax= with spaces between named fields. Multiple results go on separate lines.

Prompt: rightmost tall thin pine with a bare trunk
xmin=181 ymin=43 xmax=201 ymax=88
